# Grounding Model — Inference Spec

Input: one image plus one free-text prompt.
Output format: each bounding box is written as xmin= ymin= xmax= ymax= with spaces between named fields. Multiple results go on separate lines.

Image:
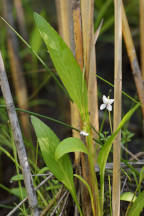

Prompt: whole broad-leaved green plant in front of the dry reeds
xmin=32 ymin=13 xmax=139 ymax=215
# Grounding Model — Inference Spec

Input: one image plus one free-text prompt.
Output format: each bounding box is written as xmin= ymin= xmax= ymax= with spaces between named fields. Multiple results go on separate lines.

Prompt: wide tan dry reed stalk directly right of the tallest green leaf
xmin=81 ymin=0 xmax=99 ymax=138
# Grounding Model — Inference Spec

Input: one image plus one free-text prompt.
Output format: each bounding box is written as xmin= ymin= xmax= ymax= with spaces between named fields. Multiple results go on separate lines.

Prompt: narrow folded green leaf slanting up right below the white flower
xmin=98 ymin=103 xmax=140 ymax=209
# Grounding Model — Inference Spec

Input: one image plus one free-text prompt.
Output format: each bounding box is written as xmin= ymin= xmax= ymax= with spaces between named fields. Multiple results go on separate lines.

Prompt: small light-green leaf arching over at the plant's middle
xmin=55 ymin=137 xmax=88 ymax=160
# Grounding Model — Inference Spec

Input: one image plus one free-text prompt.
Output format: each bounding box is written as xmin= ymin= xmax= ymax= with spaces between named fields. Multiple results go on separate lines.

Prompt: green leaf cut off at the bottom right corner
xmin=127 ymin=191 xmax=144 ymax=216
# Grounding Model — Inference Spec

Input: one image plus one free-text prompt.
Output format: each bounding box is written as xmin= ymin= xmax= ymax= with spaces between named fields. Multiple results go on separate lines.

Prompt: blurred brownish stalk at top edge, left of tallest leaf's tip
xmin=14 ymin=0 xmax=28 ymax=40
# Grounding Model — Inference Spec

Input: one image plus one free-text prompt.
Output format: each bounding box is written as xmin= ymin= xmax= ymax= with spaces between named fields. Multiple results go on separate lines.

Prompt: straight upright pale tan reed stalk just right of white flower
xmin=112 ymin=0 xmax=122 ymax=216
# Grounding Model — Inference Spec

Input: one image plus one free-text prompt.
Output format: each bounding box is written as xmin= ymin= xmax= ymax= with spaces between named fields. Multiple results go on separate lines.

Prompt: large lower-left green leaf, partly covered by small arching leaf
xmin=31 ymin=116 xmax=73 ymax=190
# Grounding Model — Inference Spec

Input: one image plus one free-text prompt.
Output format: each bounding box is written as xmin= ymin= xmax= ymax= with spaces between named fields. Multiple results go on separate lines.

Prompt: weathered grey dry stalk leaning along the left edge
xmin=0 ymin=53 xmax=39 ymax=216
